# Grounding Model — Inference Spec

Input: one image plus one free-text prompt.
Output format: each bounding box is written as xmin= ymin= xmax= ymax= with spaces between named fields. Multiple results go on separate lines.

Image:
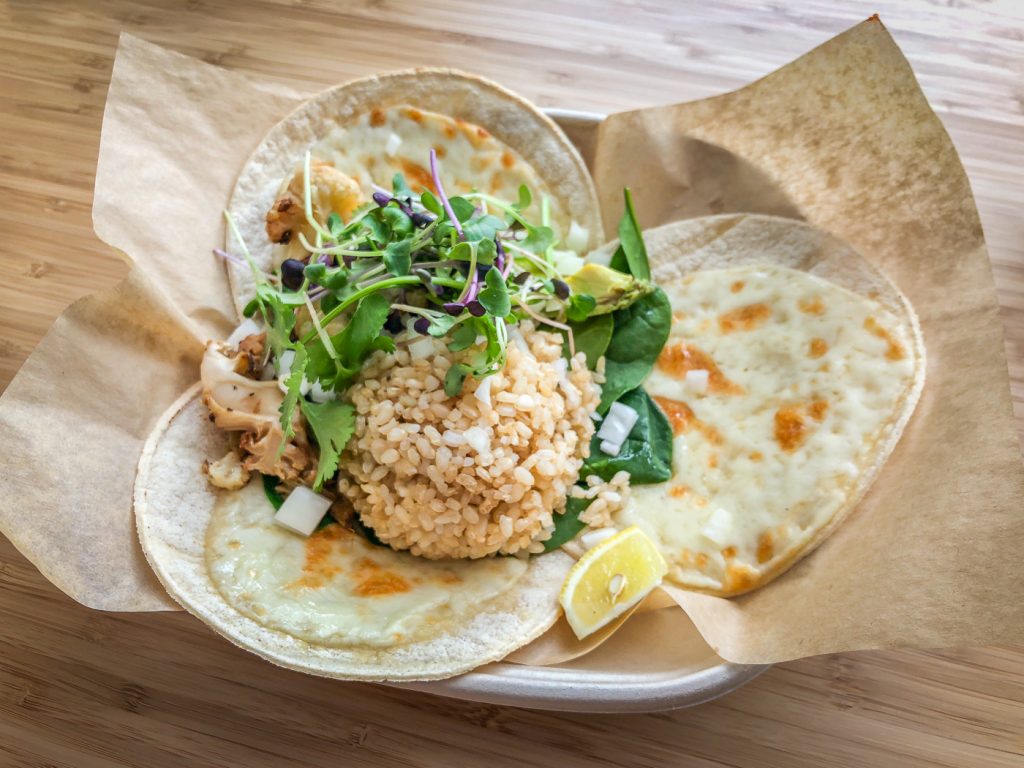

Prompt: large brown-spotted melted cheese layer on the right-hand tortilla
xmin=616 ymin=266 xmax=914 ymax=592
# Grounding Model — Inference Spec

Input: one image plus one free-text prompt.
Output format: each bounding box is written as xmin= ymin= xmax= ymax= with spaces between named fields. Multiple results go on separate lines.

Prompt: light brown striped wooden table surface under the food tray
xmin=0 ymin=0 xmax=1024 ymax=768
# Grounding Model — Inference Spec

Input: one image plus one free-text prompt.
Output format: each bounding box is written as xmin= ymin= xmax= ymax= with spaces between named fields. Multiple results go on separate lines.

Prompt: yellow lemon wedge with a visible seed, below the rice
xmin=558 ymin=525 xmax=669 ymax=640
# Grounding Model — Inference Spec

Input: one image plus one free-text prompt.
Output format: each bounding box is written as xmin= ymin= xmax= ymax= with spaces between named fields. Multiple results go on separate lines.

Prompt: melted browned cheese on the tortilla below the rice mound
xmin=206 ymin=482 xmax=527 ymax=647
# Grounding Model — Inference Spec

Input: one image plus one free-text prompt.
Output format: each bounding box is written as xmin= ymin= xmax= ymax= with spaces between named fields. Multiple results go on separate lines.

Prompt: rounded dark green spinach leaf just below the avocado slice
xmin=597 ymin=288 xmax=672 ymax=414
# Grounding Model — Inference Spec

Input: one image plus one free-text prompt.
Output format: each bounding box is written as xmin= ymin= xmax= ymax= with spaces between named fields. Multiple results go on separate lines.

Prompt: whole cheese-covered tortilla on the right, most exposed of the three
xmin=616 ymin=216 xmax=924 ymax=595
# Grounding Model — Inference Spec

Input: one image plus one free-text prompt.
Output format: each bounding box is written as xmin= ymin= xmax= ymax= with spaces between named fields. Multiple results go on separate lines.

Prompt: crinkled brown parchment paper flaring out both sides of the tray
xmin=0 ymin=20 xmax=1024 ymax=663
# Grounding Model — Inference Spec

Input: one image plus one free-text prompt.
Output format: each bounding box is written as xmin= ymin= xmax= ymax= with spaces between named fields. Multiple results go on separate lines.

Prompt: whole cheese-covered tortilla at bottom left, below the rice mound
xmin=135 ymin=387 xmax=572 ymax=680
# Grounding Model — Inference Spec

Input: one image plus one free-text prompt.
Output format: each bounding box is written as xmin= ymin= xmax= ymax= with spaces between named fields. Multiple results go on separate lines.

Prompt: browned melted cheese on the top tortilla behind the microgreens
xmin=312 ymin=106 xmax=569 ymax=236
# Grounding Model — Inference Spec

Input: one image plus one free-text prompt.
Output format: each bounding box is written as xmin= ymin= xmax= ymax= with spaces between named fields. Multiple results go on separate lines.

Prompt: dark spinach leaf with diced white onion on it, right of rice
xmin=580 ymin=387 xmax=673 ymax=485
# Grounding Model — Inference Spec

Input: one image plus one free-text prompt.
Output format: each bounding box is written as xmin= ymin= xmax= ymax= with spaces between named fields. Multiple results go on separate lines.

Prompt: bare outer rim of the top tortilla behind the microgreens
xmin=225 ymin=69 xmax=603 ymax=316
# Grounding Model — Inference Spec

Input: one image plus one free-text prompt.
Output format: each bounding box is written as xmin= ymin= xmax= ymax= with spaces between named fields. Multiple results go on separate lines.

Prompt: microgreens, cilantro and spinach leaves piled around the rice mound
xmin=226 ymin=151 xmax=672 ymax=549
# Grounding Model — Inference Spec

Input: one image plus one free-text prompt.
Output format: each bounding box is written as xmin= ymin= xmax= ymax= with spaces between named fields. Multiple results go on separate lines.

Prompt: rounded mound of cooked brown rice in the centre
xmin=338 ymin=323 xmax=600 ymax=559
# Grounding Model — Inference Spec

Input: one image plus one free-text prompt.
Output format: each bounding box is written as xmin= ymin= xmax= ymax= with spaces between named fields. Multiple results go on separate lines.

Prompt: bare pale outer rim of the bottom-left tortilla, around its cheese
xmin=134 ymin=385 xmax=572 ymax=681
